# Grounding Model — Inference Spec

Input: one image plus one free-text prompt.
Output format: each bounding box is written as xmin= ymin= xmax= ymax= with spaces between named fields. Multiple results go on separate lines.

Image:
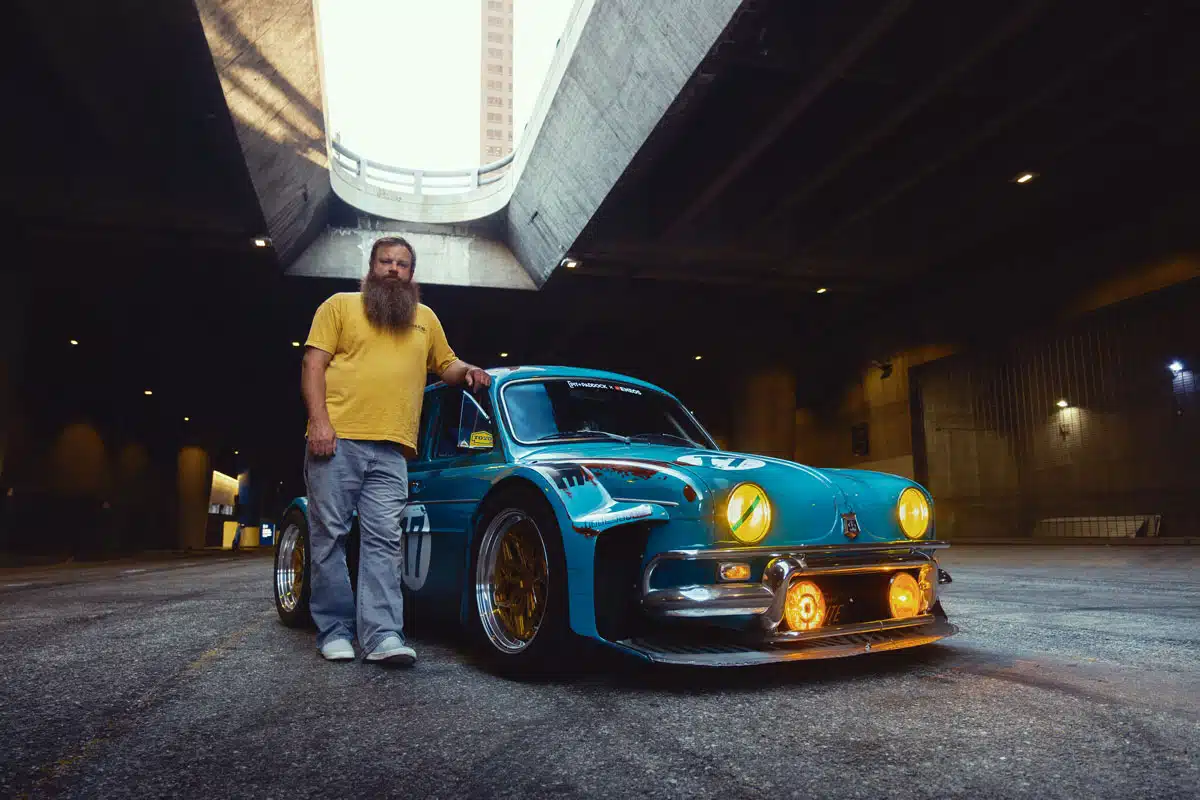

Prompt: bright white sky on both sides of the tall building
xmin=319 ymin=0 xmax=575 ymax=169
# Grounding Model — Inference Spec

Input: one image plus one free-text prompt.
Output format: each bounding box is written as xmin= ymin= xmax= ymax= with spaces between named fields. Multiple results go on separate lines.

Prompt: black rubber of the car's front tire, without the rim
xmin=467 ymin=486 xmax=571 ymax=674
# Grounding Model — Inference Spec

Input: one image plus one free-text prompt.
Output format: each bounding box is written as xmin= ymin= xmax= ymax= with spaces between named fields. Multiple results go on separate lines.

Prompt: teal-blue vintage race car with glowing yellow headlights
xmin=274 ymin=367 xmax=956 ymax=668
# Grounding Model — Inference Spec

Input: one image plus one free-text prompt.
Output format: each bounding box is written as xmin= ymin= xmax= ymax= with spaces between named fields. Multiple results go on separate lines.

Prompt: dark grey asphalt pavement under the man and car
xmin=0 ymin=546 xmax=1200 ymax=800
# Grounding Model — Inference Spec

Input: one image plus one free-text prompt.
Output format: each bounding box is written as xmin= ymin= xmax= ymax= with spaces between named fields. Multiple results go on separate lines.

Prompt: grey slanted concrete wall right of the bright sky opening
xmin=508 ymin=0 xmax=742 ymax=287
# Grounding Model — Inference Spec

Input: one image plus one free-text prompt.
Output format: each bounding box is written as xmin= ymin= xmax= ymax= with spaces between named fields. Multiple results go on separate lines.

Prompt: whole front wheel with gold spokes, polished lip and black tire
xmin=468 ymin=487 xmax=570 ymax=673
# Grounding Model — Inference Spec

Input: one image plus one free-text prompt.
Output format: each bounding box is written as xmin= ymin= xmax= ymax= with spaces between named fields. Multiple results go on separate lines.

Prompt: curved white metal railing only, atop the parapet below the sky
xmin=330 ymin=142 xmax=515 ymax=200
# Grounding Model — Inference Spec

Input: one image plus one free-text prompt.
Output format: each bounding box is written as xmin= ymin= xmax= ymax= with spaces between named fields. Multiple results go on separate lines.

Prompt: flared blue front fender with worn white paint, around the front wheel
xmin=466 ymin=462 xmax=671 ymax=638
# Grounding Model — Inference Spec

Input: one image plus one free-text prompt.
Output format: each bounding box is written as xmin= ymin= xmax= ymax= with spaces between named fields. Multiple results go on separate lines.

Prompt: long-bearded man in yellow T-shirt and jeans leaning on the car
xmin=300 ymin=236 xmax=492 ymax=666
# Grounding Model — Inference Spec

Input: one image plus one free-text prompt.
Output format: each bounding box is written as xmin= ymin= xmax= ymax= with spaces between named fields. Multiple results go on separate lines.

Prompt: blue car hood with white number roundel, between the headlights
xmin=522 ymin=441 xmax=928 ymax=546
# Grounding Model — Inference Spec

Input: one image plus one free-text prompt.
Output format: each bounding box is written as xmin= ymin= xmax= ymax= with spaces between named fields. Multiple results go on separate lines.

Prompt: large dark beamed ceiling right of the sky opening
xmin=574 ymin=0 xmax=1200 ymax=291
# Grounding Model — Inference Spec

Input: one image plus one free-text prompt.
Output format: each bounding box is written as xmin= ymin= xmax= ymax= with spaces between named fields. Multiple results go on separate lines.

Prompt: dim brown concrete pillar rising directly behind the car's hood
xmin=733 ymin=367 xmax=796 ymax=459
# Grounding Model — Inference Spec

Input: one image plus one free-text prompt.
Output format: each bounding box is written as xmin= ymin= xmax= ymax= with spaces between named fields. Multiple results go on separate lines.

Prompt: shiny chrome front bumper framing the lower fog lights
xmin=642 ymin=541 xmax=949 ymax=643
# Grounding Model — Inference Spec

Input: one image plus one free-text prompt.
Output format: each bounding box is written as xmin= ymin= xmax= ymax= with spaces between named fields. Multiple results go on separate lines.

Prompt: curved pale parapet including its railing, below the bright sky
xmin=330 ymin=142 xmax=515 ymax=222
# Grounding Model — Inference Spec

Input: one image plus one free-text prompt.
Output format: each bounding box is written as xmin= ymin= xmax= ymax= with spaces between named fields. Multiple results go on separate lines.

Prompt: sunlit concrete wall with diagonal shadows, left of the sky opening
xmin=196 ymin=0 xmax=330 ymax=264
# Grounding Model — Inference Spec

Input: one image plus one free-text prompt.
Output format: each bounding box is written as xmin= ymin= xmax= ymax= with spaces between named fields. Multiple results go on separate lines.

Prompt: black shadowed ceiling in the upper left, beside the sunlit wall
xmin=0 ymin=0 xmax=265 ymax=252
